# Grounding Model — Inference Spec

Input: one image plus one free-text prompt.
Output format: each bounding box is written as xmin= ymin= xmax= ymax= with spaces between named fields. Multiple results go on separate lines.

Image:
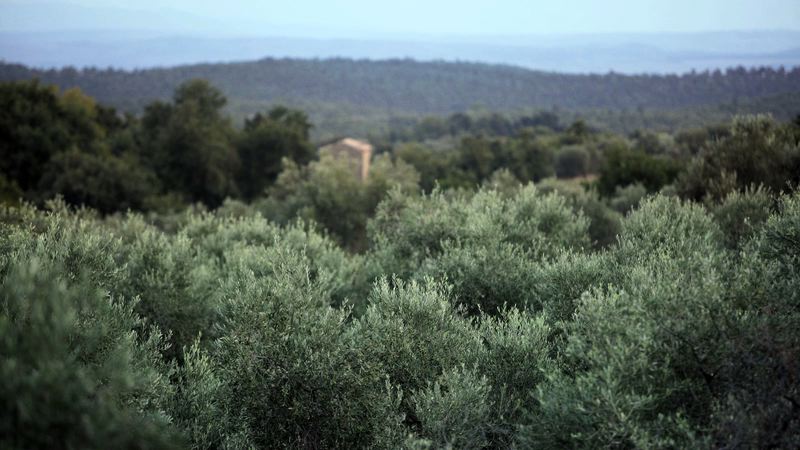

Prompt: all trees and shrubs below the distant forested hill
xmin=0 ymin=75 xmax=800 ymax=449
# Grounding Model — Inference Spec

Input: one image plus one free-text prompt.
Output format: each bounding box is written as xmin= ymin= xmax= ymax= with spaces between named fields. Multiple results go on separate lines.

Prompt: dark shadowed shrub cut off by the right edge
xmin=712 ymin=193 xmax=800 ymax=448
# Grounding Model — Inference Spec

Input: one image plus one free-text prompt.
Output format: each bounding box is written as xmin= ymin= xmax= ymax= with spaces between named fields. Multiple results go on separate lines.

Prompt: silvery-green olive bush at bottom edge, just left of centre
xmin=201 ymin=249 xmax=391 ymax=448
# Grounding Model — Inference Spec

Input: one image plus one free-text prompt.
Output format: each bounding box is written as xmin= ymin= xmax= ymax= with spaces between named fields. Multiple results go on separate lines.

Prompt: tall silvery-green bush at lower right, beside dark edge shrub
xmin=525 ymin=197 xmax=737 ymax=448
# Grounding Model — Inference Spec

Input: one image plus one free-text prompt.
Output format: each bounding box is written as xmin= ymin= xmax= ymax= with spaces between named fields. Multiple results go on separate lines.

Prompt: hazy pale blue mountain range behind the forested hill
xmin=0 ymin=31 xmax=800 ymax=74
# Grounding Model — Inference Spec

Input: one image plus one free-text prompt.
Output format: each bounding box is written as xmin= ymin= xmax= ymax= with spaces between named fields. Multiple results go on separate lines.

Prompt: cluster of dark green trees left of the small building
xmin=0 ymin=80 xmax=315 ymax=209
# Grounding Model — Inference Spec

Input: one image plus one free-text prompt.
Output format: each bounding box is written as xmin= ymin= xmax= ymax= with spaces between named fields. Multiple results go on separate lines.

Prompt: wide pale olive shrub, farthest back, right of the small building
xmin=369 ymin=185 xmax=588 ymax=276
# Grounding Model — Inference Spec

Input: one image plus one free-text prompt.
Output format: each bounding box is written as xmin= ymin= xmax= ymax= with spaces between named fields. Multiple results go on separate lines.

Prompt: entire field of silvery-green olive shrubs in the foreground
xmin=0 ymin=184 xmax=800 ymax=449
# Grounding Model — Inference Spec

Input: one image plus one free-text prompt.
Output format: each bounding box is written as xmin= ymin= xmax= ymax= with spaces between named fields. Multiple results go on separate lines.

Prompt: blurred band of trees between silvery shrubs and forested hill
xmin=0 ymin=80 xmax=800 ymax=250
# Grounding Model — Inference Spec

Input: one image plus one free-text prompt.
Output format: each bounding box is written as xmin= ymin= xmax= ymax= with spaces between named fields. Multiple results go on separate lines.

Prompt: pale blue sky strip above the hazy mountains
xmin=0 ymin=0 xmax=800 ymax=35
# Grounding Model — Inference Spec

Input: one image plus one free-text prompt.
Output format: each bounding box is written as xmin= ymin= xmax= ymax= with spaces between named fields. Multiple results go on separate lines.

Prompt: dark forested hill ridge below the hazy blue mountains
xmin=0 ymin=58 xmax=800 ymax=114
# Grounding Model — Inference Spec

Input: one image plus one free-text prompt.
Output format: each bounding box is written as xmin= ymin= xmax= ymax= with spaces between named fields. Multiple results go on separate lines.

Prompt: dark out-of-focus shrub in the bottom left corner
xmin=0 ymin=253 xmax=180 ymax=449
